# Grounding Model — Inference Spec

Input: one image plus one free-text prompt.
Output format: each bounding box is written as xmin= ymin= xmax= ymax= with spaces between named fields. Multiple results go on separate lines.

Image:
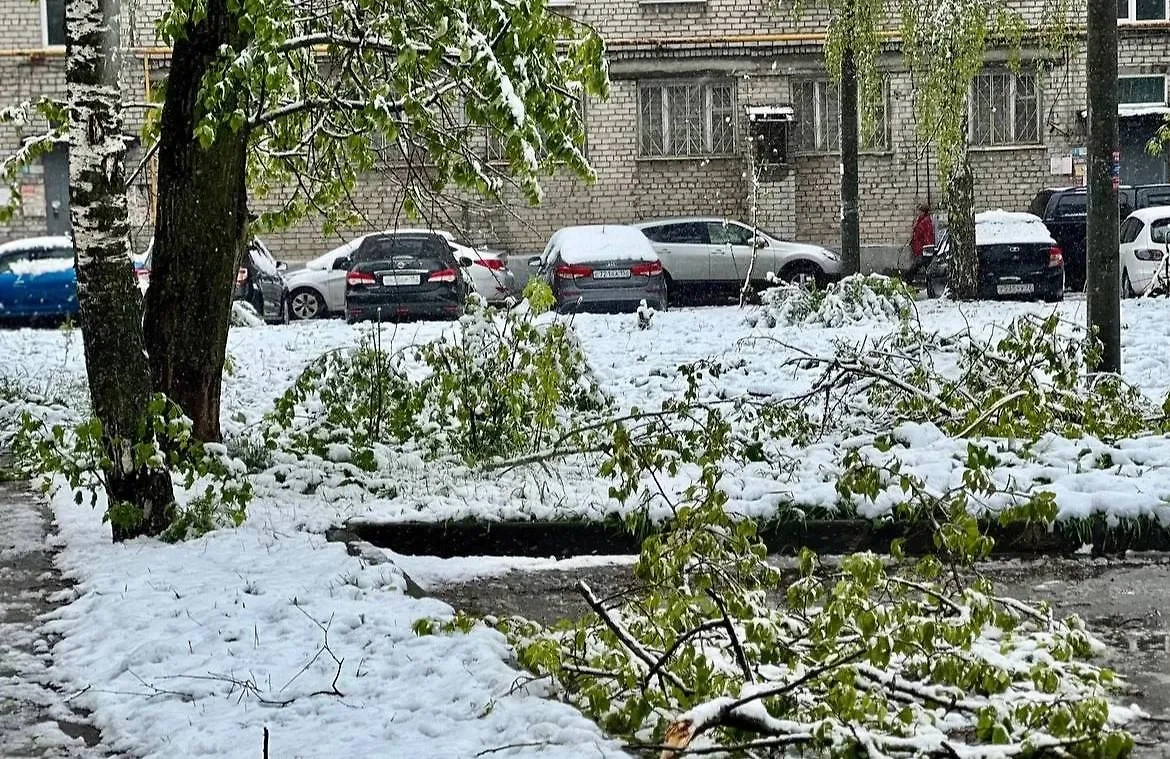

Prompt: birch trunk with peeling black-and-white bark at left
xmin=66 ymin=0 xmax=174 ymax=540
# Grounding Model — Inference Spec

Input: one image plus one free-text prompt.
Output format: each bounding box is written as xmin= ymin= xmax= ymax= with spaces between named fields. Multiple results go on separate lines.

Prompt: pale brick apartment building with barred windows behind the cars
xmin=0 ymin=0 xmax=1170 ymax=260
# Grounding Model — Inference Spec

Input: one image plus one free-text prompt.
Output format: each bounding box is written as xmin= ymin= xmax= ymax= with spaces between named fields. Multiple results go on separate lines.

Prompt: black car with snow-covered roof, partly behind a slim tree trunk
xmin=925 ymin=211 xmax=1065 ymax=303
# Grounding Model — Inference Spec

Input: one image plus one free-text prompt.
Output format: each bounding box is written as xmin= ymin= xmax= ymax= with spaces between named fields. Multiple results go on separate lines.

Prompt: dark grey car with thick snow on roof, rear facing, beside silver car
xmin=529 ymin=225 xmax=668 ymax=313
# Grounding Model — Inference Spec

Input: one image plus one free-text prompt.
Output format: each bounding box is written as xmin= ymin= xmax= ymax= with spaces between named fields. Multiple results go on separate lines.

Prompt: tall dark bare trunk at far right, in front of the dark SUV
xmin=1085 ymin=0 xmax=1121 ymax=373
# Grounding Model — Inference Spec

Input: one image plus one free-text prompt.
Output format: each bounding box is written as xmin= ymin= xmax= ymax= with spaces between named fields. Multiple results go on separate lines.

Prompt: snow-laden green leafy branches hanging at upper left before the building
xmin=151 ymin=0 xmax=608 ymax=230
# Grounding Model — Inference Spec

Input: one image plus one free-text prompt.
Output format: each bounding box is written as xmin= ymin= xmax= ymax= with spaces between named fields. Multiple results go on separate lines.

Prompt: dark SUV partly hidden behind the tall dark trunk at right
xmin=1028 ymin=185 xmax=1170 ymax=290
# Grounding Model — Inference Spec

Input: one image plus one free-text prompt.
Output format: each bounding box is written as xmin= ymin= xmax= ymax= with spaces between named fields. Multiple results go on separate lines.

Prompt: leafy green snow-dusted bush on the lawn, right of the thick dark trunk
xmin=269 ymin=292 xmax=608 ymax=470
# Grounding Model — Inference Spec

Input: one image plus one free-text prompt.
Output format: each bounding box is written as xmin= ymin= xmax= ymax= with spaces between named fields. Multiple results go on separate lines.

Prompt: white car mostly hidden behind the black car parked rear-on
xmin=287 ymin=229 xmax=516 ymax=319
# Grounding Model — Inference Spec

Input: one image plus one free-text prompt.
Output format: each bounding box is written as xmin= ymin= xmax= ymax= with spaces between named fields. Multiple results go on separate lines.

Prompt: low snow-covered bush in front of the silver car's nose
xmin=748 ymin=274 xmax=914 ymax=327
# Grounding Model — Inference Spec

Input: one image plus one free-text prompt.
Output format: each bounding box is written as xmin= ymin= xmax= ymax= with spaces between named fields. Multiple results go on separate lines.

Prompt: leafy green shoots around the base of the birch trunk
xmin=13 ymin=394 xmax=253 ymax=539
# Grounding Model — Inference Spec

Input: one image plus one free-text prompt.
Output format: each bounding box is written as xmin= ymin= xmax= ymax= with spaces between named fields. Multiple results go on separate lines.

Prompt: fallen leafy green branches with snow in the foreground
xmin=501 ymin=453 xmax=1133 ymax=757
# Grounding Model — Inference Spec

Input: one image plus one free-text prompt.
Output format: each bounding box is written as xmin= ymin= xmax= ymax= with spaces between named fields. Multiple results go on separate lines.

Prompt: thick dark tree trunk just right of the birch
xmin=145 ymin=0 xmax=248 ymax=441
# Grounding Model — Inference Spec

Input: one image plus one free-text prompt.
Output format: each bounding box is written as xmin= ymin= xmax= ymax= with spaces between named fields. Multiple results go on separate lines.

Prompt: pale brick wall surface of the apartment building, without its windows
xmin=0 ymin=0 xmax=1170 ymax=260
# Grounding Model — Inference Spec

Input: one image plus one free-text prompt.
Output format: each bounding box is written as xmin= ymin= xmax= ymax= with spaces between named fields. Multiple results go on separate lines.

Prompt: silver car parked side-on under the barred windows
xmin=632 ymin=218 xmax=841 ymax=294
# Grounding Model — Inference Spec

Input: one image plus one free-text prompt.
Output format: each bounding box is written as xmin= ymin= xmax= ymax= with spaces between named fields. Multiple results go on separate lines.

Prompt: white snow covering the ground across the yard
xmin=0 ymin=294 xmax=1170 ymax=758
